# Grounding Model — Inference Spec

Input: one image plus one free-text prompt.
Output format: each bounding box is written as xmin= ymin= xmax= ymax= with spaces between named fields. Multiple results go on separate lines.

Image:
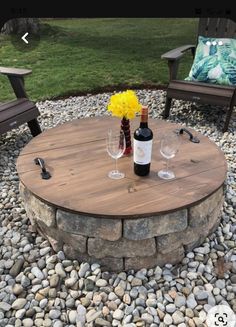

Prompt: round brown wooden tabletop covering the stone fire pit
xmin=17 ymin=117 xmax=227 ymax=218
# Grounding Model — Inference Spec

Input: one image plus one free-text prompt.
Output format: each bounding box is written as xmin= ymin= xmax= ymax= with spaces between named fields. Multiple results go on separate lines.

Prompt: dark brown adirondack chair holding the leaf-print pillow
xmin=161 ymin=18 xmax=236 ymax=132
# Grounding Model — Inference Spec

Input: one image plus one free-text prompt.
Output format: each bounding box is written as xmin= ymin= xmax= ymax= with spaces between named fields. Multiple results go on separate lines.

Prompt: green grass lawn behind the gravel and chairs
xmin=0 ymin=18 xmax=197 ymax=101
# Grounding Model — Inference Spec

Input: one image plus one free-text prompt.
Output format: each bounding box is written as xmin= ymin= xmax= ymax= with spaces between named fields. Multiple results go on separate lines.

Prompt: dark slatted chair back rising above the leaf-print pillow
xmin=198 ymin=18 xmax=236 ymax=38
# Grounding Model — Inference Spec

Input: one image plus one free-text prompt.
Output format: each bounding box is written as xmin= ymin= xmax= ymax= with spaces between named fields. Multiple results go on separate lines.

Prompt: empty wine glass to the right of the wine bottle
xmin=158 ymin=132 xmax=180 ymax=179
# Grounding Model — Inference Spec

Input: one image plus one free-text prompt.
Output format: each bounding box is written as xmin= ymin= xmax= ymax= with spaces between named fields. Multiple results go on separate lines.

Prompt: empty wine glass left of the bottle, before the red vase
xmin=107 ymin=129 xmax=125 ymax=179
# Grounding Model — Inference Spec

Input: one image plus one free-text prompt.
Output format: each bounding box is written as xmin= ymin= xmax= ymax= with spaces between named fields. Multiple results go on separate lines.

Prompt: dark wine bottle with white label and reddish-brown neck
xmin=133 ymin=106 xmax=153 ymax=176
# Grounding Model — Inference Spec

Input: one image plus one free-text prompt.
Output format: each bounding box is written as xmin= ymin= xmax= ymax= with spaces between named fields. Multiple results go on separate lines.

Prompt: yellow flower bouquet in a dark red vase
xmin=107 ymin=90 xmax=142 ymax=155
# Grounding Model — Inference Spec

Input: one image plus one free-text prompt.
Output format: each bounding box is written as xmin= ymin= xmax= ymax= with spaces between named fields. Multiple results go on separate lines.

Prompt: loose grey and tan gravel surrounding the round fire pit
xmin=0 ymin=90 xmax=236 ymax=327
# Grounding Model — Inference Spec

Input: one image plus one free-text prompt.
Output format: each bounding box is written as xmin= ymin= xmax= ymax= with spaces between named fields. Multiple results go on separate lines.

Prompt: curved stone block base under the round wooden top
xmin=20 ymin=183 xmax=224 ymax=271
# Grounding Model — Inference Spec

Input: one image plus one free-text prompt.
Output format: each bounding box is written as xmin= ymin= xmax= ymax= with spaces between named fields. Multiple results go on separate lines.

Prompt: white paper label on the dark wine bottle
xmin=134 ymin=139 xmax=152 ymax=165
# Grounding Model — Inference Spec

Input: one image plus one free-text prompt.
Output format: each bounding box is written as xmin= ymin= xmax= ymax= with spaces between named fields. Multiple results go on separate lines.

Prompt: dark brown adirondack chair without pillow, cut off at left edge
xmin=0 ymin=67 xmax=41 ymax=136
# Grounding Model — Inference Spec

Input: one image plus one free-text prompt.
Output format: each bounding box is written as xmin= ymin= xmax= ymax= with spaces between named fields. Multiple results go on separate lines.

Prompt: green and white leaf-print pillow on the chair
xmin=185 ymin=36 xmax=236 ymax=85
